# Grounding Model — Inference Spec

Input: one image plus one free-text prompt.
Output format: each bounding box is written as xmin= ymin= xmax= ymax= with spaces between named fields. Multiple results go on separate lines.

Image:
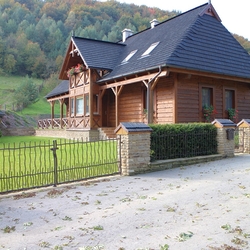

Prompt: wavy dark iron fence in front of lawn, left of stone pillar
xmin=0 ymin=137 xmax=120 ymax=193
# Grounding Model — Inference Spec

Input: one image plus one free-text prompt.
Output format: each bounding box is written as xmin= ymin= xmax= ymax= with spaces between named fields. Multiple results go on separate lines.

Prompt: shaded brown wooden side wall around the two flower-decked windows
xmin=177 ymin=74 xmax=250 ymax=123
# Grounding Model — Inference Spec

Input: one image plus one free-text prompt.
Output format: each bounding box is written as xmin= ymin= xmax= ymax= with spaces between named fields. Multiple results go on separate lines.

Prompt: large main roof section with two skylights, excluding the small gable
xmin=95 ymin=4 xmax=250 ymax=82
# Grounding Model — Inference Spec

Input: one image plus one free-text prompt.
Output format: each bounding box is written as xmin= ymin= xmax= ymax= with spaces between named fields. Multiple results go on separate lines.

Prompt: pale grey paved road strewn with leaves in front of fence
xmin=0 ymin=155 xmax=250 ymax=250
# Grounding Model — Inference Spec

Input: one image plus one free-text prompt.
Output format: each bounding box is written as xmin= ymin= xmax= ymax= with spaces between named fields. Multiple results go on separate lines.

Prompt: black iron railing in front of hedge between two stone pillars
xmin=151 ymin=130 xmax=217 ymax=161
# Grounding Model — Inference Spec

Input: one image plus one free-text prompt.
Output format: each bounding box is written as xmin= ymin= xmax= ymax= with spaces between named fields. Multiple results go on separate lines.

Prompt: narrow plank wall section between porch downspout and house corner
xmin=154 ymin=75 xmax=175 ymax=124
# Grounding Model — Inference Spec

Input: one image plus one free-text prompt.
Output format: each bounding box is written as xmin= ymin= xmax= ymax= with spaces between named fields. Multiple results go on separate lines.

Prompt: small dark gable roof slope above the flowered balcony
xmin=72 ymin=37 xmax=125 ymax=70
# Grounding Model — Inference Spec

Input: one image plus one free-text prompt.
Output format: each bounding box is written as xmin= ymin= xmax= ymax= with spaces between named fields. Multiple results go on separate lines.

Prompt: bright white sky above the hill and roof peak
xmin=114 ymin=0 xmax=250 ymax=41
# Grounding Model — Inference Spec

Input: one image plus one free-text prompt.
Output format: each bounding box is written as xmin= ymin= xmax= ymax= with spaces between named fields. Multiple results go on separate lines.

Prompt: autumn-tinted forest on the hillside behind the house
xmin=0 ymin=0 xmax=250 ymax=79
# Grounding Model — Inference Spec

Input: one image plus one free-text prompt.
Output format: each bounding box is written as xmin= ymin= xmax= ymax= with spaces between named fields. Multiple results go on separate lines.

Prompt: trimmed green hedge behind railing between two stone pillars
xmin=150 ymin=123 xmax=217 ymax=161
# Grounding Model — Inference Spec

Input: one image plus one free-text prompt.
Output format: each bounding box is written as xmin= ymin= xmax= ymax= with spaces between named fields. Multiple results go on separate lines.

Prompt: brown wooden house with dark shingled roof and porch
xmin=40 ymin=2 xmax=250 ymax=139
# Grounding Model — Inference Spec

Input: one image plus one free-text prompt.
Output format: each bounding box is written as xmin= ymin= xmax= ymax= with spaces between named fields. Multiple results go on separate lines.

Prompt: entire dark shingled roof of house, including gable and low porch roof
xmin=51 ymin=3 xmax=250 ymax=98
